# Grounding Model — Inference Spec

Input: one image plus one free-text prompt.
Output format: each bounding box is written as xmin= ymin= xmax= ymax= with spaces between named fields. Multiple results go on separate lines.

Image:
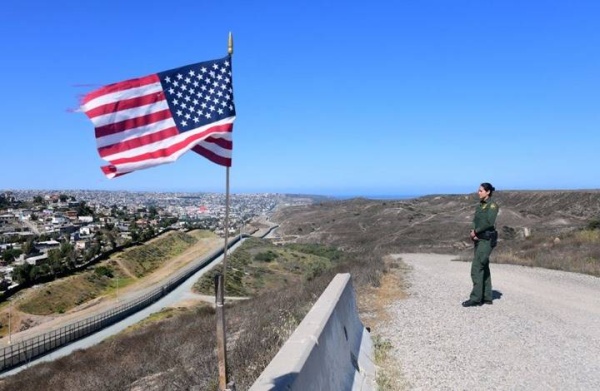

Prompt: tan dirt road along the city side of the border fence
xmin=0 ymin=231 xmax=223 ymax=347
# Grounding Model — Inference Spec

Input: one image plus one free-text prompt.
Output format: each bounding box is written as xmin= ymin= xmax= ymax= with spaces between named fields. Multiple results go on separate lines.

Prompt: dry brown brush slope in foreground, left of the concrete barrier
xmin=0 ymin=243 xmax=384 ymax=391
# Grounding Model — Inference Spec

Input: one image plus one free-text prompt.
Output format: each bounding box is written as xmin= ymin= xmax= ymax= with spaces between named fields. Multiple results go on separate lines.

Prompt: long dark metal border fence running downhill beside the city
xmin=0 ymin=234 xmax=251 ymax=373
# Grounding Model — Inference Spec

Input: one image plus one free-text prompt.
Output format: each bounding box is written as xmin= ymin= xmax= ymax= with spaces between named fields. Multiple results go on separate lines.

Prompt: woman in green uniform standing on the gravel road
xmin=462 ymin=182 xmax=499 ymax=307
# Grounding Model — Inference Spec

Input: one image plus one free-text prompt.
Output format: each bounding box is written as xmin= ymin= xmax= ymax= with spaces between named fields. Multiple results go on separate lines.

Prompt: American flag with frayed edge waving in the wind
xmin=81 ymin=56 xmax=235 ymax=178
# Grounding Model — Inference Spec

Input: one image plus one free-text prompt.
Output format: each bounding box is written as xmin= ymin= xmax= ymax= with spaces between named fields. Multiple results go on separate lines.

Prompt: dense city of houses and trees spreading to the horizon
xmin=0 ymin=190 xmax=313 ymax=291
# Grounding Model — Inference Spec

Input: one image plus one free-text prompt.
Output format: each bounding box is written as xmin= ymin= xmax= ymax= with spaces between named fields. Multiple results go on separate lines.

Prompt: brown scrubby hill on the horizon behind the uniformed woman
xmin=272 ymin=190 xmax=600 ymax=253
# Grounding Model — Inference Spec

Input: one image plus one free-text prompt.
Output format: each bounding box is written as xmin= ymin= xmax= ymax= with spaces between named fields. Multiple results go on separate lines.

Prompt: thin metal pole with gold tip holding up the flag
xmin=215 ymin=32 xmax=233 ymax=391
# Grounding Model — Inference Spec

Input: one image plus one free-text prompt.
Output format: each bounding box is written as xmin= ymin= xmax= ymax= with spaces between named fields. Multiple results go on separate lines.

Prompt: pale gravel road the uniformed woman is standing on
xmin=380 ymin=254 xmax=600 ymax=390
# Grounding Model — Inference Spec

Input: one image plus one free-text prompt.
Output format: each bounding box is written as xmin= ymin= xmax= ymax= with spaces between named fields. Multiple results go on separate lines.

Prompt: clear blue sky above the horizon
xmin=0 ymin=0 xmax=600 ymax=195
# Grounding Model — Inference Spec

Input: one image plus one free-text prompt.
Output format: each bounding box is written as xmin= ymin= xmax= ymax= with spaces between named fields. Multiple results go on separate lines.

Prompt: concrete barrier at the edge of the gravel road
xmin=250 ymin=274 xmax=376 ymax=391
